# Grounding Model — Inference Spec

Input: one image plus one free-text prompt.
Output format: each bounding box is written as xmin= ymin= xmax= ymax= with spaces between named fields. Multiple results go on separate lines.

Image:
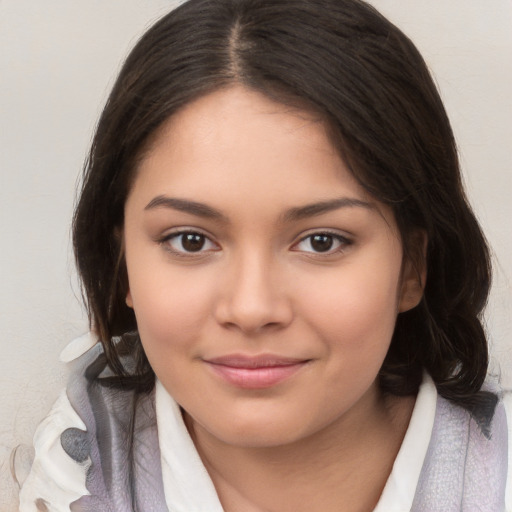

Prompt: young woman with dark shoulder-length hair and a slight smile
xmin=21 ymin=0 xmax=507 ymax=512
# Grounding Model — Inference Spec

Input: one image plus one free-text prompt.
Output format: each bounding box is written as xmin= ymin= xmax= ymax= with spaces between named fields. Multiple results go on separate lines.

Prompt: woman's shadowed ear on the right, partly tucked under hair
xmin=398 ymin=229 xmax=428 ymax=313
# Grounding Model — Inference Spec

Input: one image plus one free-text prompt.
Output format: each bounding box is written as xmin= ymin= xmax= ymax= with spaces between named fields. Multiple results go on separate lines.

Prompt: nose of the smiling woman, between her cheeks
xmin=215 ymin=252 xmax=293 ymax=334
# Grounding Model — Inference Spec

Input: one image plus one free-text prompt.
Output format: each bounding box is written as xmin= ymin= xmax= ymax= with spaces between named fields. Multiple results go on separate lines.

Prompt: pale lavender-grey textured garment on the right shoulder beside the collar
xmin=413 ymin=382 xmax=508 ymax=512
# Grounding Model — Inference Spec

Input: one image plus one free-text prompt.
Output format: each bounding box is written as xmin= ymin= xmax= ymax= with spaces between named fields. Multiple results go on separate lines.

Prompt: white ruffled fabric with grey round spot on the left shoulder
xmin=19 ymin=335 xmax=123 ymax=512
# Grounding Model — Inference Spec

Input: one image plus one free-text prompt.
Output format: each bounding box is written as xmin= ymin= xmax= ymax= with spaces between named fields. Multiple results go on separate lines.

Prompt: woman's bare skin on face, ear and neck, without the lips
xmin=124 ymin=86 xmax=424 ymax=512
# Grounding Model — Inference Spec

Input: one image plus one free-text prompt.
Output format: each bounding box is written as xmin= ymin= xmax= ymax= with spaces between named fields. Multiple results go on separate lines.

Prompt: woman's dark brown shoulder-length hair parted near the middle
xmin=73 ymin=0 xmax=496 ymax=416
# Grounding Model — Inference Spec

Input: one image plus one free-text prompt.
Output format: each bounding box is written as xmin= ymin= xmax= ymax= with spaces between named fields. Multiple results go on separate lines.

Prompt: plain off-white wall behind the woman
xmin=0 ymin=0 xmax=512 ymax=512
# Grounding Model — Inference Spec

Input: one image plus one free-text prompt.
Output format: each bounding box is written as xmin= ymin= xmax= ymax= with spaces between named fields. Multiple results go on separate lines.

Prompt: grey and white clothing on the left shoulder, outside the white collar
xmin=20 ymin=340 xmax=164 ymax=512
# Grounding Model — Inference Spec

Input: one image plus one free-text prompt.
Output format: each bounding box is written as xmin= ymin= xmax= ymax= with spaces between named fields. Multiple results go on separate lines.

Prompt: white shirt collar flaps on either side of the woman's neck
xmin=155 ymin=374 xmax=437 ymax=512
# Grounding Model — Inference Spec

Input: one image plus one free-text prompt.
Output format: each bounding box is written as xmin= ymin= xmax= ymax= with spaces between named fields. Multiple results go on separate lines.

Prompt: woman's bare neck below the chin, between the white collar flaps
xmin=186 ymin=387 xmax=414 ymax=512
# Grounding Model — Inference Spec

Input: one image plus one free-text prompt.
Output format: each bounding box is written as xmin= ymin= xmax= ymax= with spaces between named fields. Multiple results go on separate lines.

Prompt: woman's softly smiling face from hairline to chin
xmin=124 ymin=86 xmax=419 ymax=446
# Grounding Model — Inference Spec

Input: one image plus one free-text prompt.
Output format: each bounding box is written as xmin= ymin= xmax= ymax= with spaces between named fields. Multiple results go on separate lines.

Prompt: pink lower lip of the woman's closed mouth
xmin=208 ymin=361 xmax=307 ymax=389
